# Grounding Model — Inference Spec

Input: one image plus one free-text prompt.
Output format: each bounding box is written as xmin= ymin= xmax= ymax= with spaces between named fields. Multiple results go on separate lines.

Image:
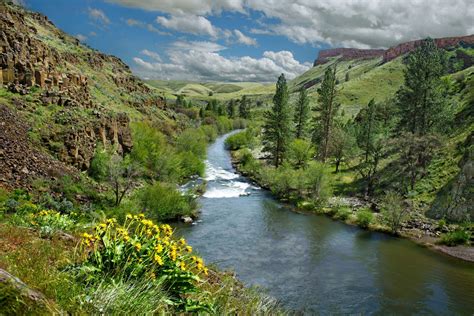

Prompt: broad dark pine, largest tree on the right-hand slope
xmin=397 ymin=39 xmax=447 ymax=135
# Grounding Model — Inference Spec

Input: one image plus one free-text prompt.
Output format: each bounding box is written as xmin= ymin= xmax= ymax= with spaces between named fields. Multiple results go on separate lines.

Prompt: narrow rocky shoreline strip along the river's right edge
xmin=231 ymin=151 xmax=474 ymax=263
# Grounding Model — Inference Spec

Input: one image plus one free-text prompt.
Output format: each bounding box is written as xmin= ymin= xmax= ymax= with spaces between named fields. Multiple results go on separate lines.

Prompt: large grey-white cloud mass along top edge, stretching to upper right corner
xmin=107 ymin=0 xmax=474 ymax=48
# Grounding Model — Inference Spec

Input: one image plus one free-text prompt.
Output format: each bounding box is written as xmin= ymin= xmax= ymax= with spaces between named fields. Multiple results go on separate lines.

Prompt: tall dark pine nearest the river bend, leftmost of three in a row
xmin=263 ymin=74 xmax=291 ymax=168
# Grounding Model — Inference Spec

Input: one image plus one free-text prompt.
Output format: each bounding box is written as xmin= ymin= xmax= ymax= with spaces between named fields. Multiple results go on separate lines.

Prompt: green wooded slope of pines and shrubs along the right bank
xmin=226 ymin=39 xmax=474 ymax=253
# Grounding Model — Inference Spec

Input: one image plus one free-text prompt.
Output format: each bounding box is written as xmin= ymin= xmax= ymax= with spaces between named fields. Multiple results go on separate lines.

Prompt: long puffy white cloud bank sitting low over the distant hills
xmin=133 ymin=41 xmax=311 ymax=82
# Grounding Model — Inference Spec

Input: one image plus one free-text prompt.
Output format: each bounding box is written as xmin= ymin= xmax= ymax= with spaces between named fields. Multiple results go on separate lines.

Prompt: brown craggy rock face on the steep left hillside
xmin=0 ymin=1 xmax=156 ymax=181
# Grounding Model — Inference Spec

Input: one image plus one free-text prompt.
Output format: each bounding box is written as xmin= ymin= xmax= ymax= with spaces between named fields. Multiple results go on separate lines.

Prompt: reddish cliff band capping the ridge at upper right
xmin=313 ymin=35 xmax=474 ymax=66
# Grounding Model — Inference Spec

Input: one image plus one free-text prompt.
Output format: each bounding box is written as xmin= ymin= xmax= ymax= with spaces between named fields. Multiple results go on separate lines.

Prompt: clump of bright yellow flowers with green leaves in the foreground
xmin=76 ymin=214 xmax=212 ymax=312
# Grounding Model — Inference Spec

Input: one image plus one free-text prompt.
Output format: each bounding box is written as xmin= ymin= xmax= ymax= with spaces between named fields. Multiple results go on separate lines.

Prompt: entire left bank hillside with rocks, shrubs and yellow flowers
xmin=0 ymin=0 xmax=282 ymax=314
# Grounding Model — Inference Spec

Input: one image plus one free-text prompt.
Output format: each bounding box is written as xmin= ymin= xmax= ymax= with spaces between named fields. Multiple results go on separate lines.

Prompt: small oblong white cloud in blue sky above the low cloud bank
xmin=156 ymin=14 xmax=219 ymax=38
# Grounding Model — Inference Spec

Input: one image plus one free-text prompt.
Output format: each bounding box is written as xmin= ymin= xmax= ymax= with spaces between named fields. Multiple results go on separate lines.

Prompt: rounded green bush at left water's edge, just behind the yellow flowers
xmin=139 ymin=182 xmax=193 ymax=220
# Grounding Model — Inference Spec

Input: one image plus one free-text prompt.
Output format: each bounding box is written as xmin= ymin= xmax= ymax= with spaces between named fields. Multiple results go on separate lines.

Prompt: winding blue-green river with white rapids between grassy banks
xmin=178 ymin=131 xmax=474 ymax=315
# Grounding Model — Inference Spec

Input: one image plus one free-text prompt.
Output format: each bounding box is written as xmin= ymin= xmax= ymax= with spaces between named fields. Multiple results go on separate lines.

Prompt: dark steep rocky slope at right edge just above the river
xmin=427 ymin=133 xmax=474 ymax=222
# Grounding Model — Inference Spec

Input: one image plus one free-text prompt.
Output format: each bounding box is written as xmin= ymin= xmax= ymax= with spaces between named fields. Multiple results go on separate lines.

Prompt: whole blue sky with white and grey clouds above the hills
xmin=22 ymin=0 xmax=474 ymax=81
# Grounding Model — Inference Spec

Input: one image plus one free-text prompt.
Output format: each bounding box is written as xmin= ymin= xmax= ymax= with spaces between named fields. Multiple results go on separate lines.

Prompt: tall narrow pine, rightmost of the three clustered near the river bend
xmin=313 ymin=66 xmax=340 ymax=162
